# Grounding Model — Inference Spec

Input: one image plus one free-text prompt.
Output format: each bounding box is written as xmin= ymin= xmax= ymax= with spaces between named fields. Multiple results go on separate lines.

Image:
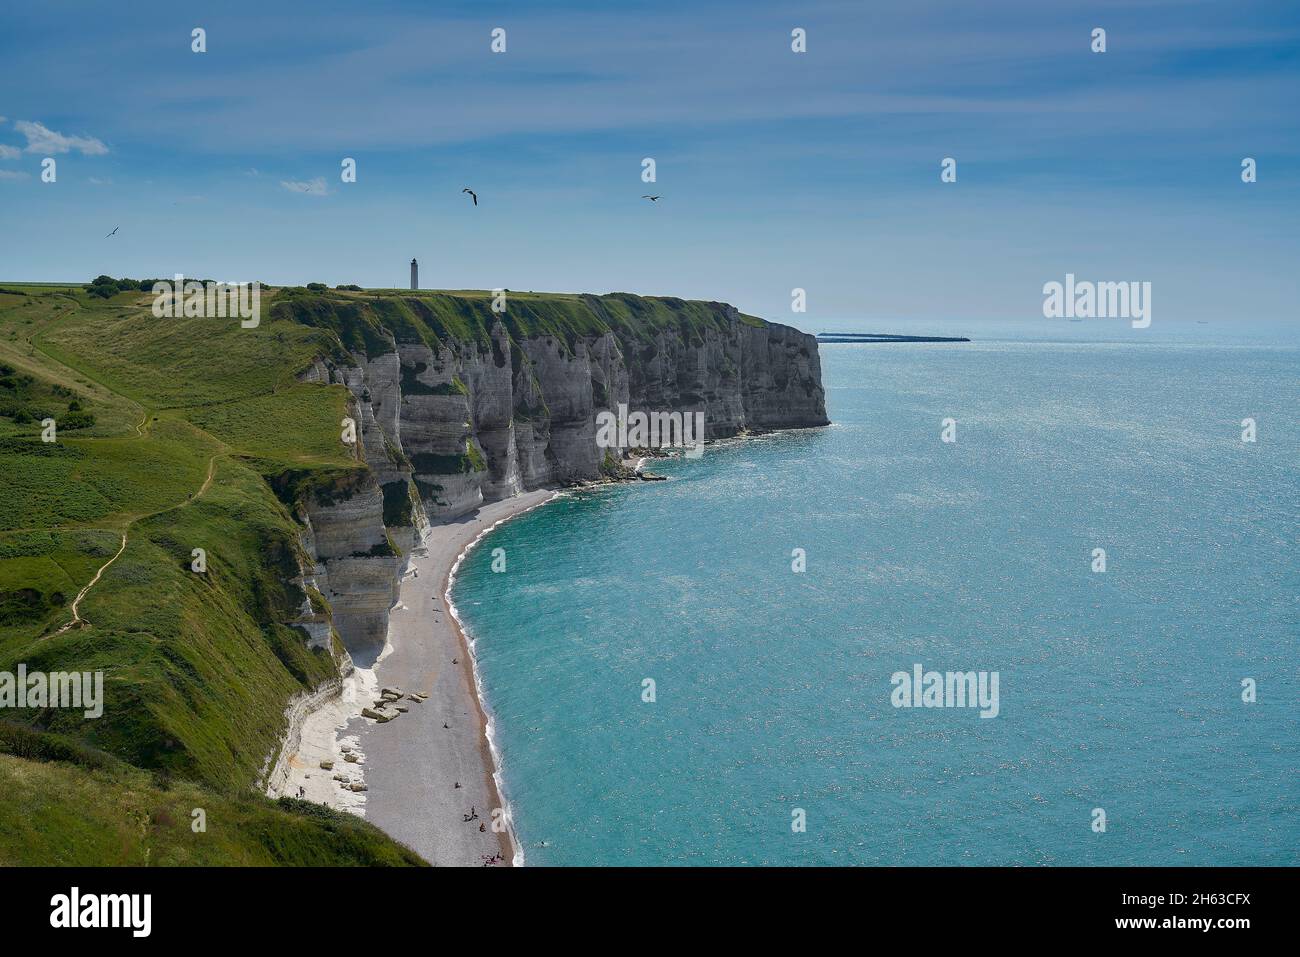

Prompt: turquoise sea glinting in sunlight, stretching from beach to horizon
xmin=452 ymin=320 xmax=1300 ymax=865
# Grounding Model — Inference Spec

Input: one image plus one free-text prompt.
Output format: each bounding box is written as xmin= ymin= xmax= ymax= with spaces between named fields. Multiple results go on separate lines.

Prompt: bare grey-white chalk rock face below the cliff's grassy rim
xmin=291 ymin=303 xmax=827 ymax=654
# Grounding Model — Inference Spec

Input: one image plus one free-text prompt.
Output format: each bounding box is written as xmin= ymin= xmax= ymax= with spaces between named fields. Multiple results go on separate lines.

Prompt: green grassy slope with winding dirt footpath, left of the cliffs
xmin=0 ymin=283 xmax=413 ymax=863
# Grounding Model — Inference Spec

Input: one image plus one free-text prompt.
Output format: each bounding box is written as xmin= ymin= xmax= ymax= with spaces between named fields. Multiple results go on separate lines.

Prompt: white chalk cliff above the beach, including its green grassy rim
xmin=287 ymin=287 xmax=827 ymax=655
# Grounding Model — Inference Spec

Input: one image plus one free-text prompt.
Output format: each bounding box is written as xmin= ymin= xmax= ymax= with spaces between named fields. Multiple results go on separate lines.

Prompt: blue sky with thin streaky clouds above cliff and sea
xmin=0 ymin=0 xmax=1300 ymax=329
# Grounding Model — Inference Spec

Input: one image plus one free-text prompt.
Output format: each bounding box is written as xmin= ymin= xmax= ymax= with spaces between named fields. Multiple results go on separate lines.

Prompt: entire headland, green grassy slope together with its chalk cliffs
xmin=0 ymin=277 xmax=824 ymax=863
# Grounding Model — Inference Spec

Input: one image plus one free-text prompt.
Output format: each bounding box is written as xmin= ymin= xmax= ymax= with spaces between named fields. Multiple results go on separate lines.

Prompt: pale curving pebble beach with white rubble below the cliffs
xmin=269 ymin=489 xmax=558 ymax=866
